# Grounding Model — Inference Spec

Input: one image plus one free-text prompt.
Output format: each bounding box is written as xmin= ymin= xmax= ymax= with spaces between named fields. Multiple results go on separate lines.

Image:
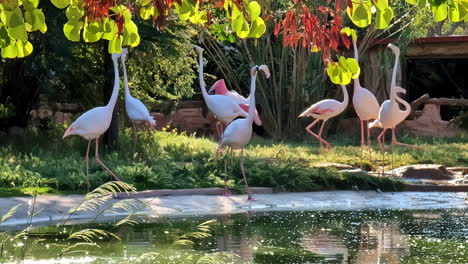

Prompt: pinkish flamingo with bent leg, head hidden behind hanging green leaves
xmin=299 ymin=85 xmax=349 ymax=149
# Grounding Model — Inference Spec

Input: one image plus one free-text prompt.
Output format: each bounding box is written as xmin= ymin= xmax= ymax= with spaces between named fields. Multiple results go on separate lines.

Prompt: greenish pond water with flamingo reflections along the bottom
xmin=0 ymin=210 xmax=468 ymax=264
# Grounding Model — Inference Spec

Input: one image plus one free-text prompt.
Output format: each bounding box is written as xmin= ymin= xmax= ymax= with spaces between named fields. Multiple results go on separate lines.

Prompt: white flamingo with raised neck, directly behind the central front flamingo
xmin=195 ymin=46 xmax=249 ymax=138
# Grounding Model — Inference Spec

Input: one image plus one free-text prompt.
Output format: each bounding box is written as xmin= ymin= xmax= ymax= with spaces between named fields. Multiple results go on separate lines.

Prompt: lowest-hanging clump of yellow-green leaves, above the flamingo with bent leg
xmin=327 ymin=57 xmax=360 ymax=85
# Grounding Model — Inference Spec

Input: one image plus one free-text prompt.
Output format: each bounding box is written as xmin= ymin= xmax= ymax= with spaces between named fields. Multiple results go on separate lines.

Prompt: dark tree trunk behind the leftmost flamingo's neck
xmin=102 ymin=48 xmax=120 ymax=150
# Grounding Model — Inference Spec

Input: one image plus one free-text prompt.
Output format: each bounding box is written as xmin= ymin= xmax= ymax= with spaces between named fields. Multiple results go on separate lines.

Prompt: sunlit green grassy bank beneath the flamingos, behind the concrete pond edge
xmin=0 ymin=128 xmax=468 ymax=196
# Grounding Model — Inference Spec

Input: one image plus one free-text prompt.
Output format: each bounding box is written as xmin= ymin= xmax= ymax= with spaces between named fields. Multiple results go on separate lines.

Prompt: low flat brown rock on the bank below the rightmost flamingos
xmin=394 ymin=164 xmax=455 ymax=180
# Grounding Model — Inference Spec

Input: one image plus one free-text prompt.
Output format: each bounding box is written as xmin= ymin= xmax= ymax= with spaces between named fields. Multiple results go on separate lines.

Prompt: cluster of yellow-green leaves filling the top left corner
xmin=0 ymin=0 xmax=47 ymax=58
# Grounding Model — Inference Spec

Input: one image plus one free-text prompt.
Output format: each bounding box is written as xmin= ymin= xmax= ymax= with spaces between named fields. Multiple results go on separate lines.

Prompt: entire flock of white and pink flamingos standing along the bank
xmin=63 ymin=37 xmax=417 ymax=196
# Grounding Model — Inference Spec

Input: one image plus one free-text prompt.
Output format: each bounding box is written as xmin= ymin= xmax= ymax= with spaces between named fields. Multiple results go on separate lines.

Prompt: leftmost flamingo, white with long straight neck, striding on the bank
xmin=63 ymin=51 xmax=125 ymax=191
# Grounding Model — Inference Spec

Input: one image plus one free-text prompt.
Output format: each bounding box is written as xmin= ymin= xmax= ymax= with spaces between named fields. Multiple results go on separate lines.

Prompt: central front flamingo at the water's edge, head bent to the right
xmin=217 ymin=65 xmax=270 ymax=200
